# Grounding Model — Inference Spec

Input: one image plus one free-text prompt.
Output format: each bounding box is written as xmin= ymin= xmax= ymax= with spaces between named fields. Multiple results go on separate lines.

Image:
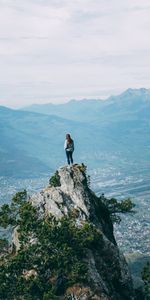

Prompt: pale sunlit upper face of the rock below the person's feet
xmin=31 ymin=167 xmax=91 ymax=219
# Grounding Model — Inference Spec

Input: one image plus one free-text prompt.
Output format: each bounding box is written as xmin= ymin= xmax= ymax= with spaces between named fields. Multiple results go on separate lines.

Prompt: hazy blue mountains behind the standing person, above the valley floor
xmin=0 ymin=89 xmax=150 ymax=177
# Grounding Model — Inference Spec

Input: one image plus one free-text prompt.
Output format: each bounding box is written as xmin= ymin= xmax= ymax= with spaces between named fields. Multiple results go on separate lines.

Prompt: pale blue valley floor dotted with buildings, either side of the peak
xmin=0 ymin=165 xmax=150 ymax=255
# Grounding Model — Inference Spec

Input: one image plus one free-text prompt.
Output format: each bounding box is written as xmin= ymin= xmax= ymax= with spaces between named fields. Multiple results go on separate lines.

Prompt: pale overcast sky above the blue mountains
xmin=0 ymin=0 xmax=150 ymax=107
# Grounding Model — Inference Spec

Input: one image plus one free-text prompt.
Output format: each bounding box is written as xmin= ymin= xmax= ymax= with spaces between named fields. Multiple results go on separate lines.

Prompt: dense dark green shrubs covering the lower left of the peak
xmin=0 ymin=191 xmax=103 ymax=300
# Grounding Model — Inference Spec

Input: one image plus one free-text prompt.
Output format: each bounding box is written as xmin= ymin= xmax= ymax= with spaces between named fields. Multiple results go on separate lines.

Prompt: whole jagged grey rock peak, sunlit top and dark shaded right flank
xmin=14 ymin=165 xmax=134 ymax=300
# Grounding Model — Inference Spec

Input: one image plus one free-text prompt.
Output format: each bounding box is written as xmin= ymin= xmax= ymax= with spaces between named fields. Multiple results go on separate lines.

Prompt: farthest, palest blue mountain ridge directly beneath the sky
xmin=23 ymin=88 xmax=150 ymax=122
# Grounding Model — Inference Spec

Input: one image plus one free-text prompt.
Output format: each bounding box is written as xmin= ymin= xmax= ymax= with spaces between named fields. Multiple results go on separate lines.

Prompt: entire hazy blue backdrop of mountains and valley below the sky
xmin=0 ymin=89 xmax=150 ymax=255
